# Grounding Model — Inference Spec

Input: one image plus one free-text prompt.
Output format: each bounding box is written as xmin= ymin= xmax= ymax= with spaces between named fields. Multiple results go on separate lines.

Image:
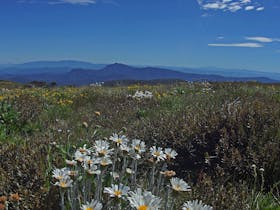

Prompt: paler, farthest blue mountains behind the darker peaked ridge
xmin=0 ymin=60 xmax=280 ymax=81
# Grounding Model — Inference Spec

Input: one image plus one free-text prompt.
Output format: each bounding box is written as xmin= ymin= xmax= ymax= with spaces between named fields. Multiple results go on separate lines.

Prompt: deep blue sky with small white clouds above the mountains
xmin=0 ymin=0 xmax=280 ymax=72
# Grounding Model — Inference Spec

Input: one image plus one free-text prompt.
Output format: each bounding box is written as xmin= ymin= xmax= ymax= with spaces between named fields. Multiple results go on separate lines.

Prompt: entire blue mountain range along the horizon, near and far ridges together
xmin=0 ymin=60 xmax=280 ymax=86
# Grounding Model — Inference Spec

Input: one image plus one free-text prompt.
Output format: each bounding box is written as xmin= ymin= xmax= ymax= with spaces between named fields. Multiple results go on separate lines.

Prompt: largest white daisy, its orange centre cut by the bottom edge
xmin=127 ymin=188 xmax=161 ymax=210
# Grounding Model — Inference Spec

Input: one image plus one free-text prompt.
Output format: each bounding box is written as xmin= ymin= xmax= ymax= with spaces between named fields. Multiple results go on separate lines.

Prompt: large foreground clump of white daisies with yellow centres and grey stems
xmin=52 ymin=134 xmax=212 ymax=210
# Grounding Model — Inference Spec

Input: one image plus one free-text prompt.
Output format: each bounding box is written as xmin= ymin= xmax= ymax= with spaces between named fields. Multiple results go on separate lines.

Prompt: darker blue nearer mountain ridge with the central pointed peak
xmin=0 ymin=63 xmax=279 ymax=86
